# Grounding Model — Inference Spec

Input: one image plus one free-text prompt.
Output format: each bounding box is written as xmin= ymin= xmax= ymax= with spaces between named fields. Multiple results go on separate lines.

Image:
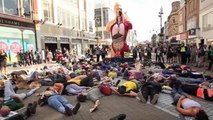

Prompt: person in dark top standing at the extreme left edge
xmin=0 ymin=50 xmax=7 ymax=75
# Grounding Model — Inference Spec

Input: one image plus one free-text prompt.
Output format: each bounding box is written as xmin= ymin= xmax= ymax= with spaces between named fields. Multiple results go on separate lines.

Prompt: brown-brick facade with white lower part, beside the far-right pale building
xmin=186 ymin=0 xmax=200 ymax=44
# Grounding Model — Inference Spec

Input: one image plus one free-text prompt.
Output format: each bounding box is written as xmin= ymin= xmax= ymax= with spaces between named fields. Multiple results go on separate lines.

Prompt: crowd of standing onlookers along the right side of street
xmin=132 ymin=43 xmax=213 ymax=70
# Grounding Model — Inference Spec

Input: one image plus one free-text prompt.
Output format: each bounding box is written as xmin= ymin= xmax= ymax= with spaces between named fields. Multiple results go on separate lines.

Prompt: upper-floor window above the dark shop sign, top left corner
xmin=4 ymin=0 xmax=19 ymax=16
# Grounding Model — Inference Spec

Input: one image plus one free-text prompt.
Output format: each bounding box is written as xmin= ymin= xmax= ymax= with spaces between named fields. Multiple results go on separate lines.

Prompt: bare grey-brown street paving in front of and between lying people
xmin=5 ymin=64 xmax=213 ymax=120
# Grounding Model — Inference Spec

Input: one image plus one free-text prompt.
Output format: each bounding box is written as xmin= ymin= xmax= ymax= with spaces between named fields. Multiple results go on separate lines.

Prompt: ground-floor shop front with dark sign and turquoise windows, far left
xmin=0 ymin=18 xmax=36 ymax=64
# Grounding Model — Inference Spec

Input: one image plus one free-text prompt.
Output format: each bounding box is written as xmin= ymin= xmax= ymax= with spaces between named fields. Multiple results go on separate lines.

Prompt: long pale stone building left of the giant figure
xmin=36 ymin=0 xmax=95 ymax=55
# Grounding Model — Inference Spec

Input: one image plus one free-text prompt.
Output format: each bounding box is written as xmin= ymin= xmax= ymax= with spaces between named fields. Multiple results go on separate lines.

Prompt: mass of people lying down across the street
xmin=0 ymin=42 xmax=213 ymax=120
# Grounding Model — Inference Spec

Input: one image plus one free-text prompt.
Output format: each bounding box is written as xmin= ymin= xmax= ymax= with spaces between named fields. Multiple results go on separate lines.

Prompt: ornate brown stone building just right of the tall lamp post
xmin=168 ymin=1 xmax=180 ymax=40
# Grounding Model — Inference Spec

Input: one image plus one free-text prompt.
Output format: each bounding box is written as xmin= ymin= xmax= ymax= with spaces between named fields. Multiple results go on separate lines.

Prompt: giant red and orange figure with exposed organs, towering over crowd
xmin=106 ymin=3 xmax=132 ymax=57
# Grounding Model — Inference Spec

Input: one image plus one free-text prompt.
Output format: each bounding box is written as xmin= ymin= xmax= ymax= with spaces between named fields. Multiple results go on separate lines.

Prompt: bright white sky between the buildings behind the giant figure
xmin=96 ymin=0 xmax=177 ymax=42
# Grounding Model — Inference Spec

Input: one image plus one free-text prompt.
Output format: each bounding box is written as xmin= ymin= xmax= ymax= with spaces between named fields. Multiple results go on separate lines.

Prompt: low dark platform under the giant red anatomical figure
xmin=105 ymin=57 xmax=135 ymax=63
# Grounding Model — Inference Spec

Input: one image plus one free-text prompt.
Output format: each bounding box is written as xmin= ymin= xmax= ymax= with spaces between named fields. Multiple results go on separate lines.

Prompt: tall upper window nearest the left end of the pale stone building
xmin=42 ymin=0 xmax=53 ymax=22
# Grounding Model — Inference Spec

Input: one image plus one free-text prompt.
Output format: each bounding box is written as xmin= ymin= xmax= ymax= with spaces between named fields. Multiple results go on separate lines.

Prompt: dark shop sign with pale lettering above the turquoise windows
xmin=0 ymin=18 xmax=34 ymax=28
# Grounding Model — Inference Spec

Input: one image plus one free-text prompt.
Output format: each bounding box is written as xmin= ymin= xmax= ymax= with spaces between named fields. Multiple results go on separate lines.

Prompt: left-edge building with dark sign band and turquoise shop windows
xmin=0 ymin=0 xmax=37 ymax=63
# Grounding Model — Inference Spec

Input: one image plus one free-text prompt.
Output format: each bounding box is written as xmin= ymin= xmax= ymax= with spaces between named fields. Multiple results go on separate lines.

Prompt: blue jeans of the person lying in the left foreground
xmin=47 ymin=95 xmax=74 ymax=113
